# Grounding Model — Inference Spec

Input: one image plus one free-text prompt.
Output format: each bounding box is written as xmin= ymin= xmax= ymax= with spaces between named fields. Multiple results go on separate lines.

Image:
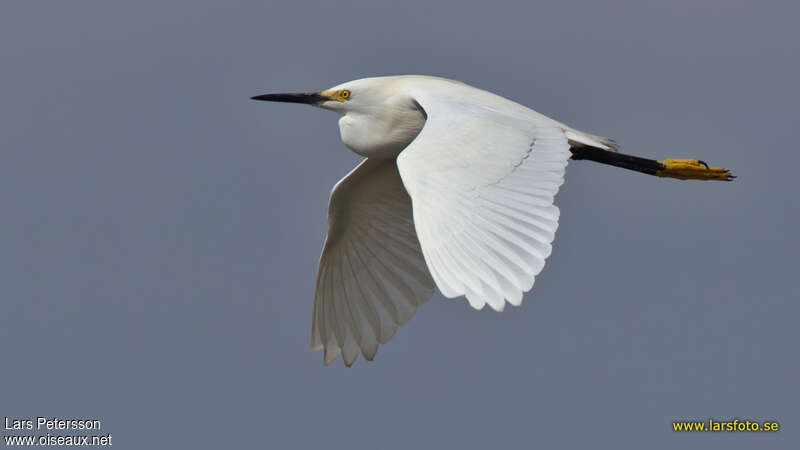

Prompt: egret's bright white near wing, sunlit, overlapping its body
xmin=397 ymin=85 xmax=570 ymax=311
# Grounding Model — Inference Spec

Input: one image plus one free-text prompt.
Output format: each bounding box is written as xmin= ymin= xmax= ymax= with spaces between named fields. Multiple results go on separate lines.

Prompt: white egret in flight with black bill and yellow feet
xmin=252 ymin=75 xmax=734 ymax=367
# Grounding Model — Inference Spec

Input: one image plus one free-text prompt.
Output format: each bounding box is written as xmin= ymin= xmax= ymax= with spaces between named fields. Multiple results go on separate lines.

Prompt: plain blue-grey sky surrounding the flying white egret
xmin=0 ymin=0 xmax=800 ymax=449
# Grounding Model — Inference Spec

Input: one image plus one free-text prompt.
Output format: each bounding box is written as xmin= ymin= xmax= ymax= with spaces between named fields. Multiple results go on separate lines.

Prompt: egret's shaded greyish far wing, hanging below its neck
xmin=311 ymin=159 xmax=433 ymax=366
